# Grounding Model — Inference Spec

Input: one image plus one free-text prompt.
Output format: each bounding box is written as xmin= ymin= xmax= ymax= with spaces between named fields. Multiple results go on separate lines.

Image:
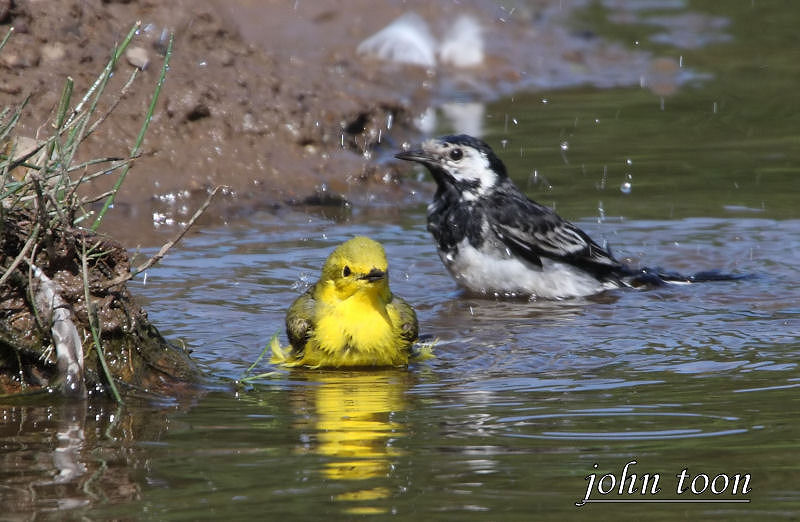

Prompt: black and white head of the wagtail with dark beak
xmin=395 ymin=134 xmax=508 ymax=201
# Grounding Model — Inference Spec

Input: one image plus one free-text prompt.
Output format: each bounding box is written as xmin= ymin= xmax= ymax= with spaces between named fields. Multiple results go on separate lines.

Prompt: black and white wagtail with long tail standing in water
xmin=395 ymin=134 xmax=736 ymax=299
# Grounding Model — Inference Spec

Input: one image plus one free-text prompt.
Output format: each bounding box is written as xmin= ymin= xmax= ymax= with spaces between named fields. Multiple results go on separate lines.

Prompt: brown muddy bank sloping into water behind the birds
xmin=0 ymin=0 xmax=688 ymax=246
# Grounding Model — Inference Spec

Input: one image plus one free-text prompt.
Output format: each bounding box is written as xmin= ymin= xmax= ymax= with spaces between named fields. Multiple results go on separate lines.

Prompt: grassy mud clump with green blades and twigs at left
xmin=0 ymin=23 xmax=209 ymax=402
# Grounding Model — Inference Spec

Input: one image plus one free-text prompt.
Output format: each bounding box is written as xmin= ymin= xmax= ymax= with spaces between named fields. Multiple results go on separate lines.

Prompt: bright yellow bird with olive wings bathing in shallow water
xmin=286 ymin=237 xmax=419 ymax=367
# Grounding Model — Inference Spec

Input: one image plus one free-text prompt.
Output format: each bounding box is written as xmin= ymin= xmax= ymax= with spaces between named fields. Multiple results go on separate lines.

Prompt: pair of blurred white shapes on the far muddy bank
xmin=356 ymin=12 xmax=484 ymax=68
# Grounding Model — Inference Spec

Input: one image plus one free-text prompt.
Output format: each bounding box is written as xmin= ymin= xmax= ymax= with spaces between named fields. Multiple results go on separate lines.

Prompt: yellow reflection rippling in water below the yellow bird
xmin=295 ymin=370 xmax=410 ymax=513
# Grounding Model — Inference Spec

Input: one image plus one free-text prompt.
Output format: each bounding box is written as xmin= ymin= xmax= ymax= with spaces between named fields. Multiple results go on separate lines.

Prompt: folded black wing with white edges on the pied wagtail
xmin=487 ymin=188 xmax=620 ymax=268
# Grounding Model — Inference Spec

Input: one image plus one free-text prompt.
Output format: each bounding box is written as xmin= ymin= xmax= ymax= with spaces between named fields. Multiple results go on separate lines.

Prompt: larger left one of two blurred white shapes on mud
xmin=356 ymin=12 xmax=436 ymax=67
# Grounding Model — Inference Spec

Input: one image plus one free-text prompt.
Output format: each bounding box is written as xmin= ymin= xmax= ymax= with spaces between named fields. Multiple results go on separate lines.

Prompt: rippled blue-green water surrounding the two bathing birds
xmin=0 ymin=2 xmax=800 ymax=520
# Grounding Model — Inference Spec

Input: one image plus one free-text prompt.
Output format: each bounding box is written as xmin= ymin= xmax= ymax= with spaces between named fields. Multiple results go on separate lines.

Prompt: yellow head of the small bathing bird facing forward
xmin=322 ymin=236 xmax=389 ymax=299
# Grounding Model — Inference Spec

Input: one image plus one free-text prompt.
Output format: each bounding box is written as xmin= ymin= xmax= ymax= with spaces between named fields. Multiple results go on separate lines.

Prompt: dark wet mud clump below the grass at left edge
xmin=0 ymin=205 xmax=199 ymax=396
